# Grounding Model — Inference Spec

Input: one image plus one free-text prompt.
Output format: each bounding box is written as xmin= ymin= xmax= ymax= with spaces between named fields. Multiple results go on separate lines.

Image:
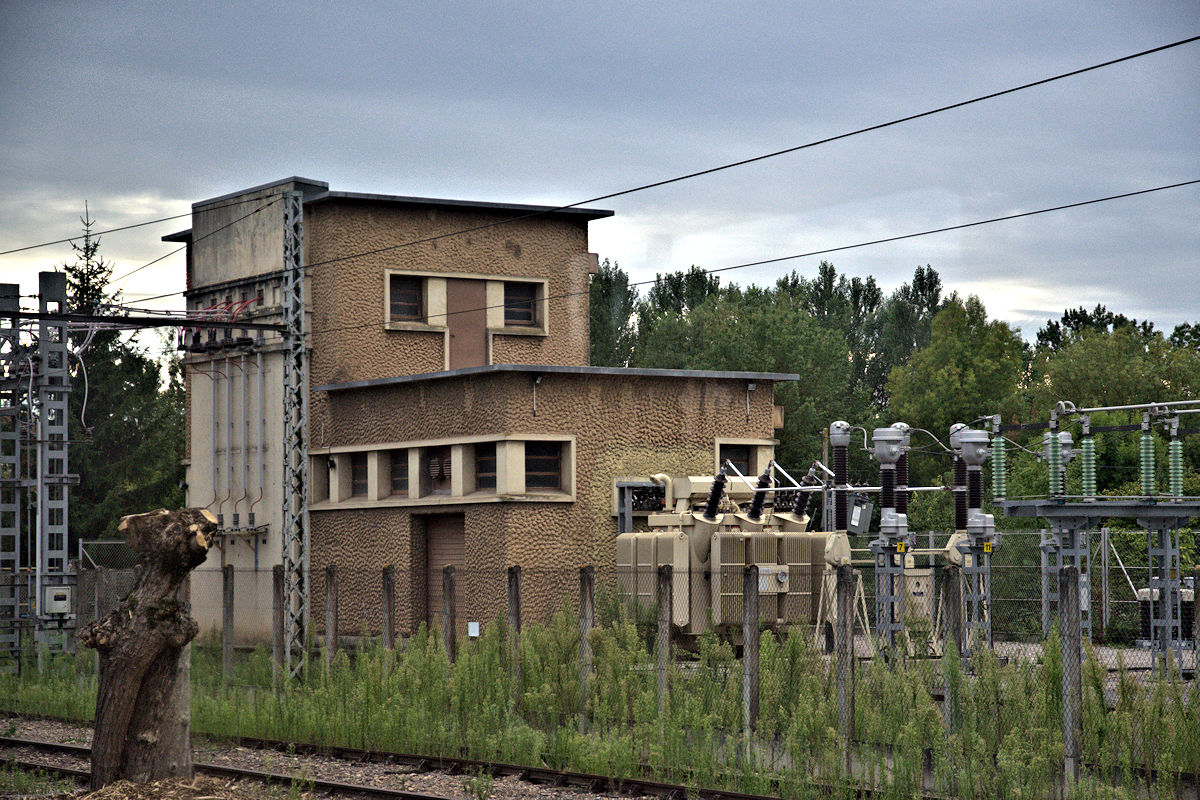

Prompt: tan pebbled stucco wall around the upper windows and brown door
xmin=305 ymin=200 xmax=593 ymax=393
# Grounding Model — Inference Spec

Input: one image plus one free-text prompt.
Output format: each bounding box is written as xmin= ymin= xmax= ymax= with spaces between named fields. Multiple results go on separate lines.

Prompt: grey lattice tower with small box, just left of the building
xmin=34 ymin=272 xmax=71 ymax=643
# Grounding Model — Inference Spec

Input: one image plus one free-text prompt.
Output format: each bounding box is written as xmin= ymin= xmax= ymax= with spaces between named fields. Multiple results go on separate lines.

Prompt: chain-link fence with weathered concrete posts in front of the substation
xmin=37 ymin=531 xmax=1200 ymax=798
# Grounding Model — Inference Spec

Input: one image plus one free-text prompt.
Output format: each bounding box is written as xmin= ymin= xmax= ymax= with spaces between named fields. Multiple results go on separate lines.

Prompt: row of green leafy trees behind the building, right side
xmin=590 ymin=260 xmax=1200 ymax=513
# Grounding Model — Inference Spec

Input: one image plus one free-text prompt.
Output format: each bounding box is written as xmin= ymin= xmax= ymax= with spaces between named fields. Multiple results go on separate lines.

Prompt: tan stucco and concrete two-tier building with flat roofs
xmin=174 ymin=178 xmax=797 ymax=639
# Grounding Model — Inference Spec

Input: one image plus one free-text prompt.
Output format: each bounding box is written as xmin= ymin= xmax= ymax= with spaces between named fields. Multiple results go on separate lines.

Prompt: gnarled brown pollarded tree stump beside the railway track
xmin=79 ymin=509 xmax=217 ymax=789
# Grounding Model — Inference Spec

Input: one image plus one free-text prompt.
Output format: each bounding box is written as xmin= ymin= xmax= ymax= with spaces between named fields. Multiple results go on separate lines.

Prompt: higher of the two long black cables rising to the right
xmin=100 ymin=35 xmax=1200 ymax=302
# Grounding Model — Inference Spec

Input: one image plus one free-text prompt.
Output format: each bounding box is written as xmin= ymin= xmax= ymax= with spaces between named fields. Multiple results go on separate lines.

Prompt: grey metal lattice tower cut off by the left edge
xmin=0 ymin=283 xmax=22 ymax=654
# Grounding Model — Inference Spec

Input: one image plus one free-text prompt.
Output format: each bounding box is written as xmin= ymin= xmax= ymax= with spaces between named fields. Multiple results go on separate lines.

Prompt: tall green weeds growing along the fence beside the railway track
xmin=0 ymin=610 xmax=1200 ymax=800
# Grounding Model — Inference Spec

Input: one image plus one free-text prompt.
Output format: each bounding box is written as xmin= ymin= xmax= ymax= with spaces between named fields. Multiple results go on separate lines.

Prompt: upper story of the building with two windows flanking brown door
xmin=166 ymin=178 xmax=612 ymax=385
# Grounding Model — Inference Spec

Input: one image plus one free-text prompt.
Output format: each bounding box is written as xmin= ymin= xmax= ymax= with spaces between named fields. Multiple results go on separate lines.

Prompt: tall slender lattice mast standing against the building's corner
xmin=282 ymin=192 xmax=310 ymax=676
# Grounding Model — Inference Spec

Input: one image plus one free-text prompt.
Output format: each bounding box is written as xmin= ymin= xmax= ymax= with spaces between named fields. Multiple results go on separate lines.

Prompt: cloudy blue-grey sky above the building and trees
xmin=0 ymin=0 xmax=1200 ymax=337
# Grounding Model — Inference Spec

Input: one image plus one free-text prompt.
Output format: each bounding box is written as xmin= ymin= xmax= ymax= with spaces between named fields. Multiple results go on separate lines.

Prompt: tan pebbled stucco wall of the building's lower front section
xmin=311 ymin=373 xmax=774 ymax=631
